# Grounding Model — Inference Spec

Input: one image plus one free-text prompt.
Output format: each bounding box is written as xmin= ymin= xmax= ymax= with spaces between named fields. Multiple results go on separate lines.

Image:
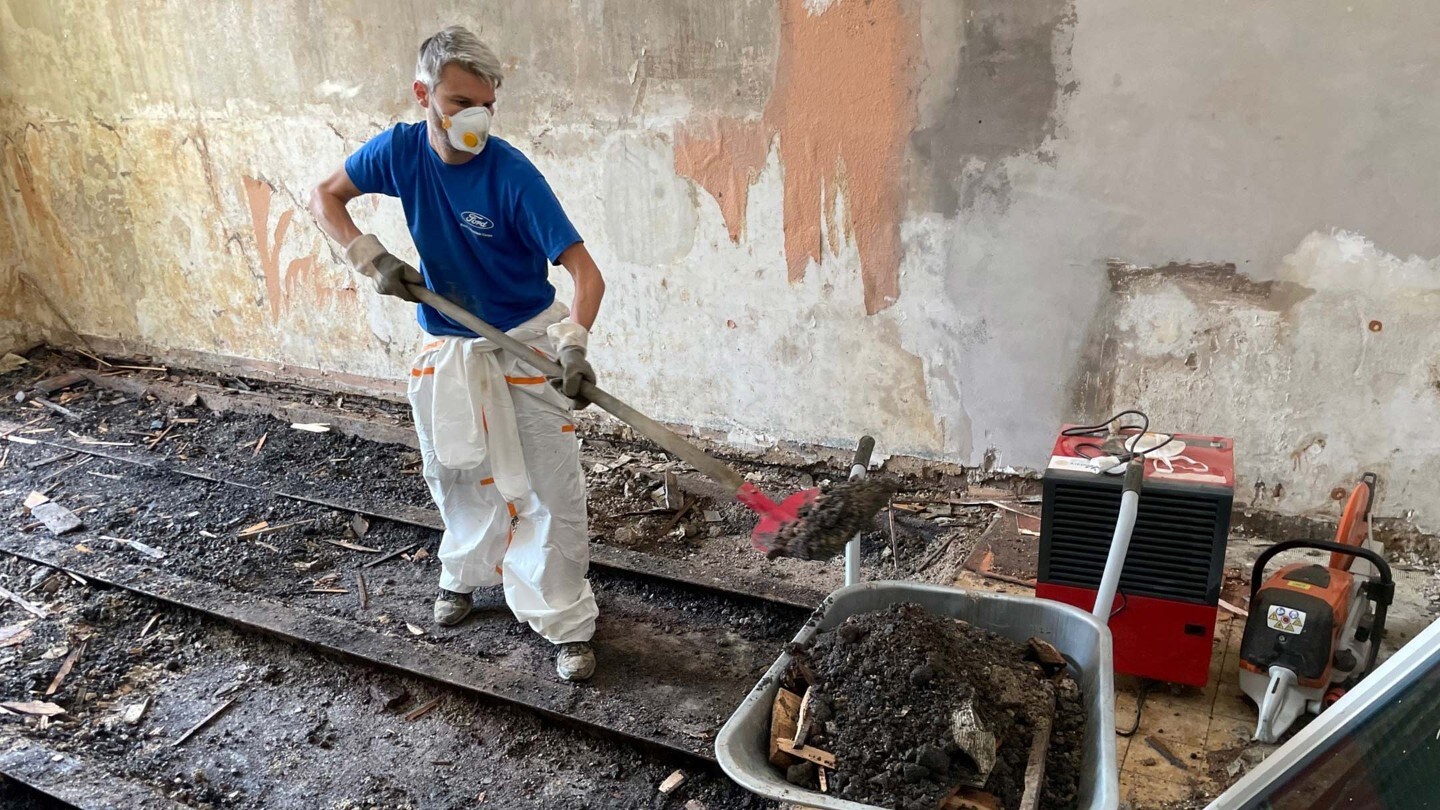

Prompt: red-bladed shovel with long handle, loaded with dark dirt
xmin=406 ymin=284 xmax=891 ymax=559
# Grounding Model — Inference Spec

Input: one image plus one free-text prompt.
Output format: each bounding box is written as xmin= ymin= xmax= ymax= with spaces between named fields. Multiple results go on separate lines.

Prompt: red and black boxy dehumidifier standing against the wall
xmin=1035 ymin=427 xmax=1236 ymax=686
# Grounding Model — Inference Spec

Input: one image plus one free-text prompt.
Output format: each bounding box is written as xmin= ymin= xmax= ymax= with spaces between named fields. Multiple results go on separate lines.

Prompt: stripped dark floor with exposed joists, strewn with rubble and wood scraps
xmin=0 ymin=350 xmax=1013 ymax=807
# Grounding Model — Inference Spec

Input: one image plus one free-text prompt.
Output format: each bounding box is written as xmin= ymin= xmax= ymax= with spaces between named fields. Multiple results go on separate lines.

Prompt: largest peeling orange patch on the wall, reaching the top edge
xmin=675 ymin=0 xmax=919 ymax=314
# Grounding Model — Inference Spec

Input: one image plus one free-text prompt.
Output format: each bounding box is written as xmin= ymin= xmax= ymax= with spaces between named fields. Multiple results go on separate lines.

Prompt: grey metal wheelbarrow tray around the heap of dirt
xmin=716 ymin=582 xmax=1120 ymax=810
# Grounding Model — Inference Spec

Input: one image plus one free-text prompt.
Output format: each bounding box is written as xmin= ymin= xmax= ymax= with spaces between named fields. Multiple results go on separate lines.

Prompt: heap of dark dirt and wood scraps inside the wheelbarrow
xmin=772 ymin=604 xmax=1086 ymax=810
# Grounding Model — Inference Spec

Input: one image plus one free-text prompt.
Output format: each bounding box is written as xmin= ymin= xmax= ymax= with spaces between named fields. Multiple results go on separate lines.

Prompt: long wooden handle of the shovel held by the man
xmin=406 ymin=284 xmax=744 ymax=493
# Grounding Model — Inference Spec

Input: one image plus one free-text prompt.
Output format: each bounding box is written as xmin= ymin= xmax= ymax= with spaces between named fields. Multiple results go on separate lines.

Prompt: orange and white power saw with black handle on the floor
xmin=1240 ymin=473 xmax=1395 ymax=742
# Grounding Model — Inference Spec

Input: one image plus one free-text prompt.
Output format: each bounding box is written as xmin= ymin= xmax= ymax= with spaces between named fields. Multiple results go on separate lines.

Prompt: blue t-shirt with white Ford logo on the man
xmin=346 ymin=123 xmax=580 ymax=337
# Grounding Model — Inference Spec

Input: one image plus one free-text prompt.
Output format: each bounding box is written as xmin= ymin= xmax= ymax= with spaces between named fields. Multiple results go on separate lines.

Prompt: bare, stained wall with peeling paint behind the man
xmin=0 ymin=0 xmax=1440 ymax=529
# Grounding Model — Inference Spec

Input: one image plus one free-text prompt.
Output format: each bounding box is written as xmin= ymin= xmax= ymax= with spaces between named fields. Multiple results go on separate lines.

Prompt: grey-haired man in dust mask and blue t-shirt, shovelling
xmin=310 ymin=26 xmax=605 ymax=680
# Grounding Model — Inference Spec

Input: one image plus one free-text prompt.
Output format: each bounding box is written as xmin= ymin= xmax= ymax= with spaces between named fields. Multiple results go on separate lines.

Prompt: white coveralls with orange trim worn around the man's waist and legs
xmin=409 ymin=301 xmax=599 ymax=644
